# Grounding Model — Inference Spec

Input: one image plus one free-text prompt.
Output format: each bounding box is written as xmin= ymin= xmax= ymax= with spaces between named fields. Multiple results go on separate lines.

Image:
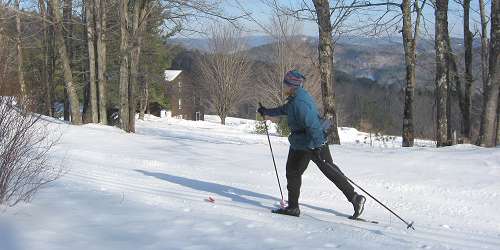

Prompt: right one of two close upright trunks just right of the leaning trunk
xmin=94 ymin=0 xmax=108 ymax=125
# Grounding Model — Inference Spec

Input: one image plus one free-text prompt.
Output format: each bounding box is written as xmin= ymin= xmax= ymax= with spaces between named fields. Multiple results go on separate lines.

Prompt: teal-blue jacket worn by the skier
xmin=264 ymin=87 xmax=326 ymax=150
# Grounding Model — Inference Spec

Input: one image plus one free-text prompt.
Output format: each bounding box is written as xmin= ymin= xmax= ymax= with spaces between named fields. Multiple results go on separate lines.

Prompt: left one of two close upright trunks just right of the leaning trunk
xmin=85 ymin=0 xmax=99 ymax=123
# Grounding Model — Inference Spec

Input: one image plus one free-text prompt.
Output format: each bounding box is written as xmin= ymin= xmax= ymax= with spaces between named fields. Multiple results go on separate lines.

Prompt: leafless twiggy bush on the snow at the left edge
xmin=0 ymin=97 xmax=62 ymax=206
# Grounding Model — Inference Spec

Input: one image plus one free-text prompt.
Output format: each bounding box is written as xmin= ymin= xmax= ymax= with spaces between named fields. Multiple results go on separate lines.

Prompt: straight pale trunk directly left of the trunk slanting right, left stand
xmin=120 ymin=0 xmax=130 ymax=132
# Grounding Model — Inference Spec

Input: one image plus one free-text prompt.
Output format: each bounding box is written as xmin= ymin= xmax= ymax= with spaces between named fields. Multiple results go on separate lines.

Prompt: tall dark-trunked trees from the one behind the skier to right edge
xmin=247 ymin=0 xmax=500 ymax=147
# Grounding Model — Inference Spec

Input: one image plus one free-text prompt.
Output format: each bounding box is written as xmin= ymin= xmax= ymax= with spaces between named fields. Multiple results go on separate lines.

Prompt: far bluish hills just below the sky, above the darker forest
xmin=169 ymin=36 xmax=482 ymax=91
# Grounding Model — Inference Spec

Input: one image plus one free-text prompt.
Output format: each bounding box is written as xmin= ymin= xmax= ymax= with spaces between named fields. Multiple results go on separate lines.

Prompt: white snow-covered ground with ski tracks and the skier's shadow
xmin=0 ymin=116 xmax=500 ymax=250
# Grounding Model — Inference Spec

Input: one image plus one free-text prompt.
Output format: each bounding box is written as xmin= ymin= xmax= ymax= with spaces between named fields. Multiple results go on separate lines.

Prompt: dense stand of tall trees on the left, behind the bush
xmin=0 ymin=0 xmax=233 ymax=129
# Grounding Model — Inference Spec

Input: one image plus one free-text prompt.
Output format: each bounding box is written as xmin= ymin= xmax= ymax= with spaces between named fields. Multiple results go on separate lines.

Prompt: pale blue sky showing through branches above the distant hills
xmin=181 ymin=0 xmax=490 ymax=37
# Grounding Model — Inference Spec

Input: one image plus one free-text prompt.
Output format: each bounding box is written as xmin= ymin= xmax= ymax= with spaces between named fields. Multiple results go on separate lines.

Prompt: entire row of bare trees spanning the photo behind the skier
xmin=0 ymin=0 xmax=500 ymax=147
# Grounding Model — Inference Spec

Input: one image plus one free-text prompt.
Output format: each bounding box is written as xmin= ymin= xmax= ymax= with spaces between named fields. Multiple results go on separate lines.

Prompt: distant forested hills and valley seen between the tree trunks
xmin=167 ymin=37 xmax=482 ymax=139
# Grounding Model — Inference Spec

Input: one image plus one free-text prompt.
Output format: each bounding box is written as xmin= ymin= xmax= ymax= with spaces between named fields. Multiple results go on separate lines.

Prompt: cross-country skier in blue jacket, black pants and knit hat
xmin=257 ymin=70 xmax=366 ymax=219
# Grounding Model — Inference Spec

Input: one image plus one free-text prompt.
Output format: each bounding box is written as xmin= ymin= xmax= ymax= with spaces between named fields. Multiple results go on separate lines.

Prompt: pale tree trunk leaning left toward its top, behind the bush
xmin=50 ymin=0 xmax=82 ymax=125
